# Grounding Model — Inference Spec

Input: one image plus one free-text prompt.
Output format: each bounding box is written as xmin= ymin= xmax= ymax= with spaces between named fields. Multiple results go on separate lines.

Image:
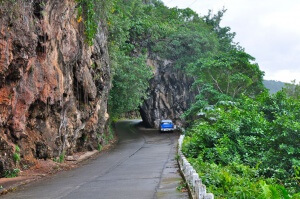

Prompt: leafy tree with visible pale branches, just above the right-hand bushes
xmin=187 ymin=49 xmax=264 ymax=98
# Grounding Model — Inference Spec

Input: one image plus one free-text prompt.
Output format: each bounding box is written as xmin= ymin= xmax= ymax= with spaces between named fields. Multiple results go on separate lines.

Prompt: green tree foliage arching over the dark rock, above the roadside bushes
xmin=102 ymin=0 xmax=263 ymax=118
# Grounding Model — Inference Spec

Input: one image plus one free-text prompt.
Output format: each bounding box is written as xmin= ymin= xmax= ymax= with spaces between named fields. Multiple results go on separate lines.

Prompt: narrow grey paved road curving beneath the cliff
xmin=3 ymin=121 xmax=188 ymax=199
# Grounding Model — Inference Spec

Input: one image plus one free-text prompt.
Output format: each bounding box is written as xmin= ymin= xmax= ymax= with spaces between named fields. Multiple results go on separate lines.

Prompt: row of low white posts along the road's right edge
xmin=178 ymin=135 xmax=214 ymax=199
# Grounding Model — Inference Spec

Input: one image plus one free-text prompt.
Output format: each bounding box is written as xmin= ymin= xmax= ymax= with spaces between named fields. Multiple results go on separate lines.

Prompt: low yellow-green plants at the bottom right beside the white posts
xmin=190 ymin=158 xmax=299 ymax=199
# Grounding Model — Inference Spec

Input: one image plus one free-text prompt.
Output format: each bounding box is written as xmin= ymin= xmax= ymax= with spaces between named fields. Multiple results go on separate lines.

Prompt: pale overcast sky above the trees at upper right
xmin=162 ymin=0 xmax=300 ymax=82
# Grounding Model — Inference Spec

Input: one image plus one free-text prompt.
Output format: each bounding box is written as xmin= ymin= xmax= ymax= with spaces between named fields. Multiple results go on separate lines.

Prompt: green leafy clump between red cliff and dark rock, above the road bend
xmin=109 ymin=54 xmax=152 ymax=117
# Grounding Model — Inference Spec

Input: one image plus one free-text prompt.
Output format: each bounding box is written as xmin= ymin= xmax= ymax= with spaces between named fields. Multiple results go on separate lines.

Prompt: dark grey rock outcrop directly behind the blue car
xmin=140 ymin=59 xmax=197 ymax=128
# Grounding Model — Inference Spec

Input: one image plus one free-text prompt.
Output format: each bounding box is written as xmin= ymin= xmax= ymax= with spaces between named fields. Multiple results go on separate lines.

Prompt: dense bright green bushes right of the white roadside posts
xmin=183 ymin=92 xmax=300 ymax=198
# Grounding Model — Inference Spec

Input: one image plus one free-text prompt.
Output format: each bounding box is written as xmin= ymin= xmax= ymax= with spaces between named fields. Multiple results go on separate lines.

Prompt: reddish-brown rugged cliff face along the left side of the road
xmin=0 ymin=0 xmax=110 ymax=174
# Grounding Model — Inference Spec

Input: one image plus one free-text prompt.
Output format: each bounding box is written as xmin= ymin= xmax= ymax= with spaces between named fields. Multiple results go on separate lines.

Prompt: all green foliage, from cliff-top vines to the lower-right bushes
xmin=77 ymin=0 xmax=300 ymax=198
